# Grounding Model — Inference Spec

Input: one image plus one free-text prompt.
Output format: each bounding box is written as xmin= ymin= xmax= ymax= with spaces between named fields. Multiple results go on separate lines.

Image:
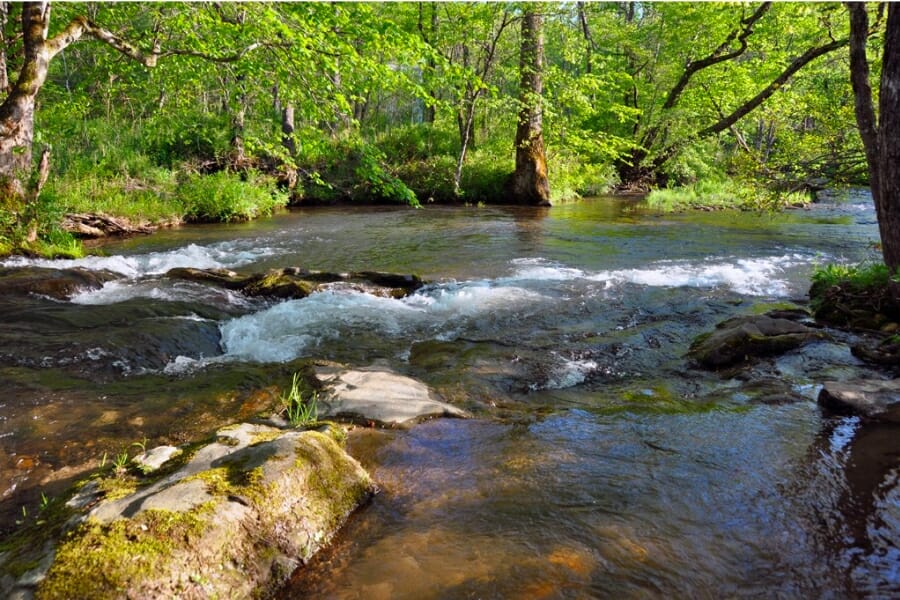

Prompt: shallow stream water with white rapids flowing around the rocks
xmin=0 ymin=196 xmax=900 ymax=599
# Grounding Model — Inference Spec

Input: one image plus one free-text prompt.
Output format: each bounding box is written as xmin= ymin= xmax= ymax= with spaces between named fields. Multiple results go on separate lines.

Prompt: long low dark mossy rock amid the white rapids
xmin=166 ymin=267 xmax=424 ymax=299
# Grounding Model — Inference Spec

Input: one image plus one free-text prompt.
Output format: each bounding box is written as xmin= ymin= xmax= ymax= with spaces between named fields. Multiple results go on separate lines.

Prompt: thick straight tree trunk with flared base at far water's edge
xmin=507 ymin=6 xmax=550 ymax=206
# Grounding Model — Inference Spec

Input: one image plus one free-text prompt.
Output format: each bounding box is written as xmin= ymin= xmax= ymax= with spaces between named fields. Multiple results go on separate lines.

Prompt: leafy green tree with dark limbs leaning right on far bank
xmin=578 ymin=2 xmax=849 ymax=187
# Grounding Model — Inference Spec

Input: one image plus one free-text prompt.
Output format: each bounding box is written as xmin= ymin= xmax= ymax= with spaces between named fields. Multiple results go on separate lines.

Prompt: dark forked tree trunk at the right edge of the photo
xmin=847 ymin=2 xmax=900 ymax=273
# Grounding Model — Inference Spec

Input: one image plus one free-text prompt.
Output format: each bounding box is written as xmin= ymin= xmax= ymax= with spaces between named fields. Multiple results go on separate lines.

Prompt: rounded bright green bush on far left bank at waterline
xmin=178 ymin=171 xmax=287 ymax=223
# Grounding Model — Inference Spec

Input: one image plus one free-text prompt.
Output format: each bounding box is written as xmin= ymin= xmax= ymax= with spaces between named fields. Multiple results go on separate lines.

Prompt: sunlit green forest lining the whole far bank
xmin=0 ymin=2 xmax=882 ymax=255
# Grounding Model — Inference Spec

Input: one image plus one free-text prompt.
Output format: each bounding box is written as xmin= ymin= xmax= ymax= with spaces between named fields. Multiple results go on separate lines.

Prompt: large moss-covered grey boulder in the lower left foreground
xmin=0 ymin=424 xmax=374 ymax=598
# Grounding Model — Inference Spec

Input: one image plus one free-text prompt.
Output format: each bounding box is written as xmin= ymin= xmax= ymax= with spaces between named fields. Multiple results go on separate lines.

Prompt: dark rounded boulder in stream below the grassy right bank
xmin=688 ymin=315 xmax=827 ymax=369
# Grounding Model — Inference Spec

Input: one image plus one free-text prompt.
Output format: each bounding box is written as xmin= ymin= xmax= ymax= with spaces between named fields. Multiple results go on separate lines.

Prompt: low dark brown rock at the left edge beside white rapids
xmin=0 ymin=267 xmax=121 ymax=300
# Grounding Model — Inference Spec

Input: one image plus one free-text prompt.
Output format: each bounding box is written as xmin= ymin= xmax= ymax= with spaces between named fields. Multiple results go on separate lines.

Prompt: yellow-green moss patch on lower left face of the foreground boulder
xmin=36 ymin=504 xmax=213 ymax=600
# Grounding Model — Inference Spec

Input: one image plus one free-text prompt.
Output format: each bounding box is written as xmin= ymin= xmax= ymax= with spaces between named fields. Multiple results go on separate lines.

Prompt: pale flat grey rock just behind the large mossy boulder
xmin=316 ymin=367 xmax=469 ymax=425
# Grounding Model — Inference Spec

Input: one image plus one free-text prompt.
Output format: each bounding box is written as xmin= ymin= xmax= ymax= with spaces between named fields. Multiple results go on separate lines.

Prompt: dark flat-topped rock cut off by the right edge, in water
xmin=819 ymin=379 xmax=900 ymax=423
